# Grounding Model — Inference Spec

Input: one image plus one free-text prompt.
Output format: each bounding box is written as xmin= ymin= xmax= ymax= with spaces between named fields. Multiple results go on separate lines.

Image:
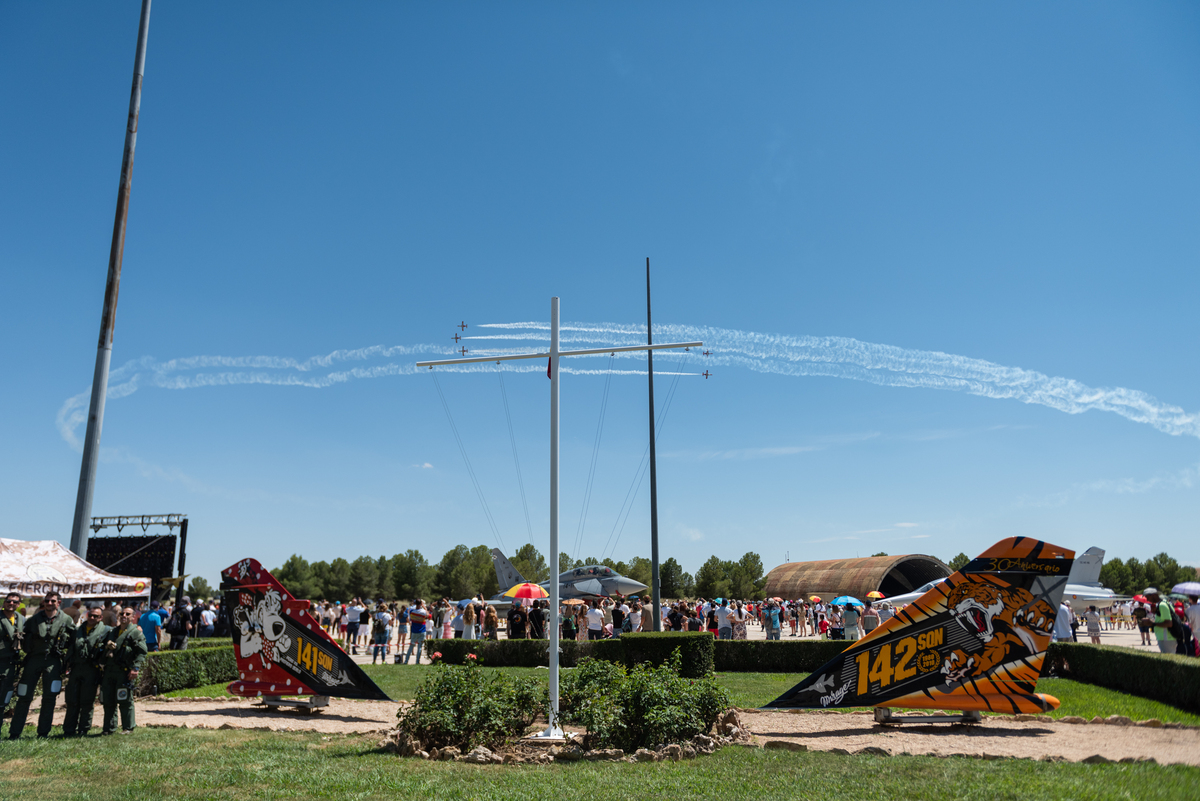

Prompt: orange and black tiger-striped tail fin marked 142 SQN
xmin=767 ymin=537 xmax=1075 ymax=723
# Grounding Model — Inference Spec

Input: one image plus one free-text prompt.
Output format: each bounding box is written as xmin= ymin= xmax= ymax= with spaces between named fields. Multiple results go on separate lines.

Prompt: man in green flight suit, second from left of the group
xmin=8 ymin=590 xmax=74 ymax=740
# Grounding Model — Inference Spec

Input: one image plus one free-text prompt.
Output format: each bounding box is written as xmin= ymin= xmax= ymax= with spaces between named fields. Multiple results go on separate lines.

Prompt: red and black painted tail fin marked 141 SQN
xmin=221 ymin=559 xmax=391 ymax=712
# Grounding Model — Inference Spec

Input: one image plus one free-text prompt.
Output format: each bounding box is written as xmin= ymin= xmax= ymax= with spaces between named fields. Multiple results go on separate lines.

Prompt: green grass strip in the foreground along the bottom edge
xmin=0 ymin=729 xmax=1200 ymax=801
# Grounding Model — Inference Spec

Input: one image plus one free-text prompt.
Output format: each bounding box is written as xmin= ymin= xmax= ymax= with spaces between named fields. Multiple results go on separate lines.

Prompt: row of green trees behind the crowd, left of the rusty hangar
xmin=266 ymin=543 xmax=766 ymax=601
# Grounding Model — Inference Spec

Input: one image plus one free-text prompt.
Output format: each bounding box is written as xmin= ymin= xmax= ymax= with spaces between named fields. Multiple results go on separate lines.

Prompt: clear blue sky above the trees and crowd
xmin=0 ymin=1 xmax=1200 ymax=580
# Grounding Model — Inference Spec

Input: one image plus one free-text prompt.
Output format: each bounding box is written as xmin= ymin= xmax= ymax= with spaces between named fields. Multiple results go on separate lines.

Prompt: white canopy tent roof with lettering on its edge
xmin=0 ymin=537 xmax=150 ymax=598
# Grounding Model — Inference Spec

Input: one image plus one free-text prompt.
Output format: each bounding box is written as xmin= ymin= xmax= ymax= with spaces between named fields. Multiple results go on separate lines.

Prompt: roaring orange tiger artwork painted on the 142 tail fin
xmin=942 ymin=580 xmax=1055 ymax=682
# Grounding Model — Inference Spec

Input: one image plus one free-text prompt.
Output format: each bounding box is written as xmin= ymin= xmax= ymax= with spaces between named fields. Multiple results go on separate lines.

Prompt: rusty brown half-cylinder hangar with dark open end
xmin=764 ymin=554 xmax=954 ymax=601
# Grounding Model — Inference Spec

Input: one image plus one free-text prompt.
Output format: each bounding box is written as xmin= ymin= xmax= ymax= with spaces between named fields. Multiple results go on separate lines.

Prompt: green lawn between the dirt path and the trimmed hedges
xmin=167 ymin=664 xmax=1200 ymax=725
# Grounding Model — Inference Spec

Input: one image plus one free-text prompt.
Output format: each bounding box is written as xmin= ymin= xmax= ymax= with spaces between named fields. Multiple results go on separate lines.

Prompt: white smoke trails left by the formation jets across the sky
xmin=56 ymin=321 xmax=1200 ymax=450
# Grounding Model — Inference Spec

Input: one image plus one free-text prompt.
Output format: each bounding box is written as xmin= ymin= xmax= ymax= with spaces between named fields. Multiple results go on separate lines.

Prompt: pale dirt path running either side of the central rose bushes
xmin=35 ymin=698 xmax=1200 ymax=765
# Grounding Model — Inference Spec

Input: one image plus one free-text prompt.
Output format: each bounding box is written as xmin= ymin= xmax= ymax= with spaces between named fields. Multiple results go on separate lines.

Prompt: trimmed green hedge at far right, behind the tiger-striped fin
xmin=1046 ymin=643 xmax=1200 ymax=712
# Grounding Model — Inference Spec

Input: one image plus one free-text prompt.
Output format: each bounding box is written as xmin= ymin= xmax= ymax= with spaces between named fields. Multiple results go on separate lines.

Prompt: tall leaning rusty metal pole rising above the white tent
xmin=71 ymin=0 xmax=150 ymax=558
